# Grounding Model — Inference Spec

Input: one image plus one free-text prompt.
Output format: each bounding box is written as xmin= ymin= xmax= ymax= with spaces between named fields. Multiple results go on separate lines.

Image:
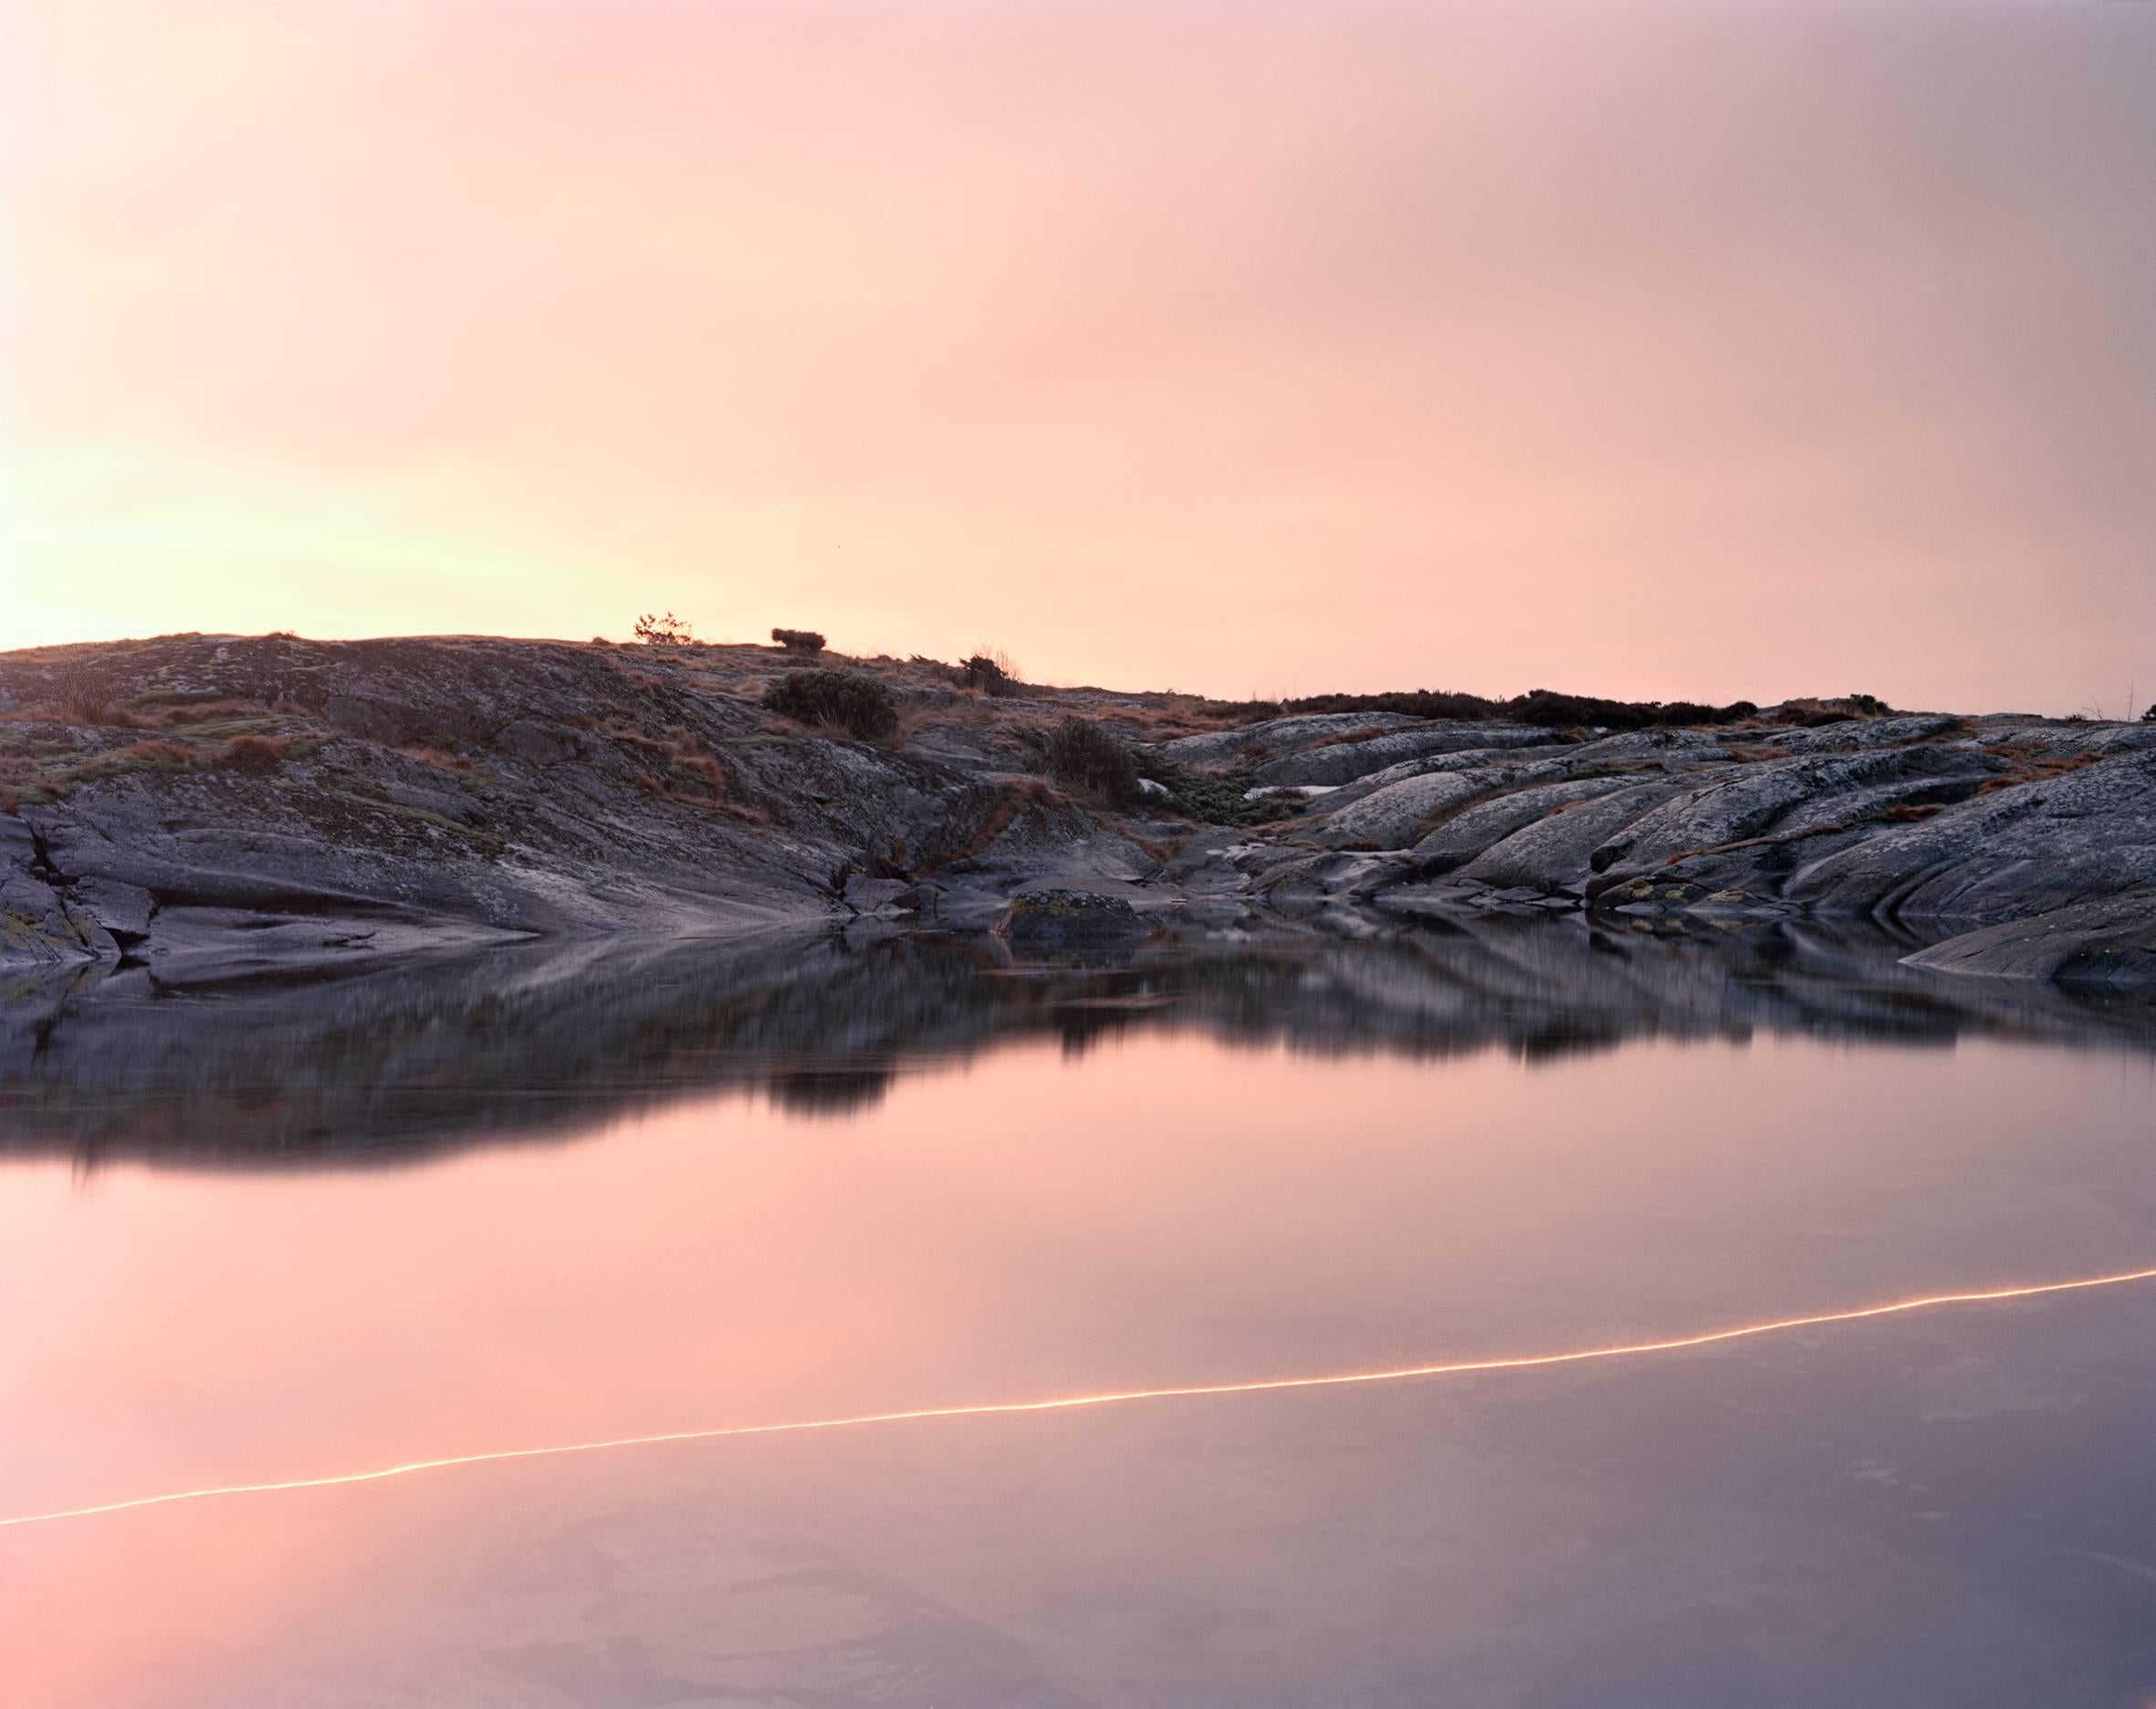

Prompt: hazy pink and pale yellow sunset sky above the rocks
xmin=0 ymin=0 xmax=2156 ymax=711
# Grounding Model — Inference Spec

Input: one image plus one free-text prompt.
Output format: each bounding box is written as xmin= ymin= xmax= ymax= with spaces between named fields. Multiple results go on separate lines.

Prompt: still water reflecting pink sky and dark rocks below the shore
xmin=0 ymin=925 xmax=2156 ymax=1709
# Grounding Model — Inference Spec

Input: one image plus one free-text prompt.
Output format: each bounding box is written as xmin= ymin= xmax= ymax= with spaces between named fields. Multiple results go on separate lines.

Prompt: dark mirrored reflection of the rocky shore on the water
xmin=0 ymin=920 xmax=2156 ymax=1168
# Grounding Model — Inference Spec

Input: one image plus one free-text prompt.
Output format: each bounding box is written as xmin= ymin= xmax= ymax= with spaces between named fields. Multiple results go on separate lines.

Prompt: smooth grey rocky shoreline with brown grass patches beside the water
xmin=0 ymin=635 xmax=2156 ymax=990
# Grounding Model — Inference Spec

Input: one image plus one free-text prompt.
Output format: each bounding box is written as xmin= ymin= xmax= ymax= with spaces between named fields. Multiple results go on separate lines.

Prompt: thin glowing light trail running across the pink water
xmin=0 ymin=1267 xmax=2156 ymax=1530
